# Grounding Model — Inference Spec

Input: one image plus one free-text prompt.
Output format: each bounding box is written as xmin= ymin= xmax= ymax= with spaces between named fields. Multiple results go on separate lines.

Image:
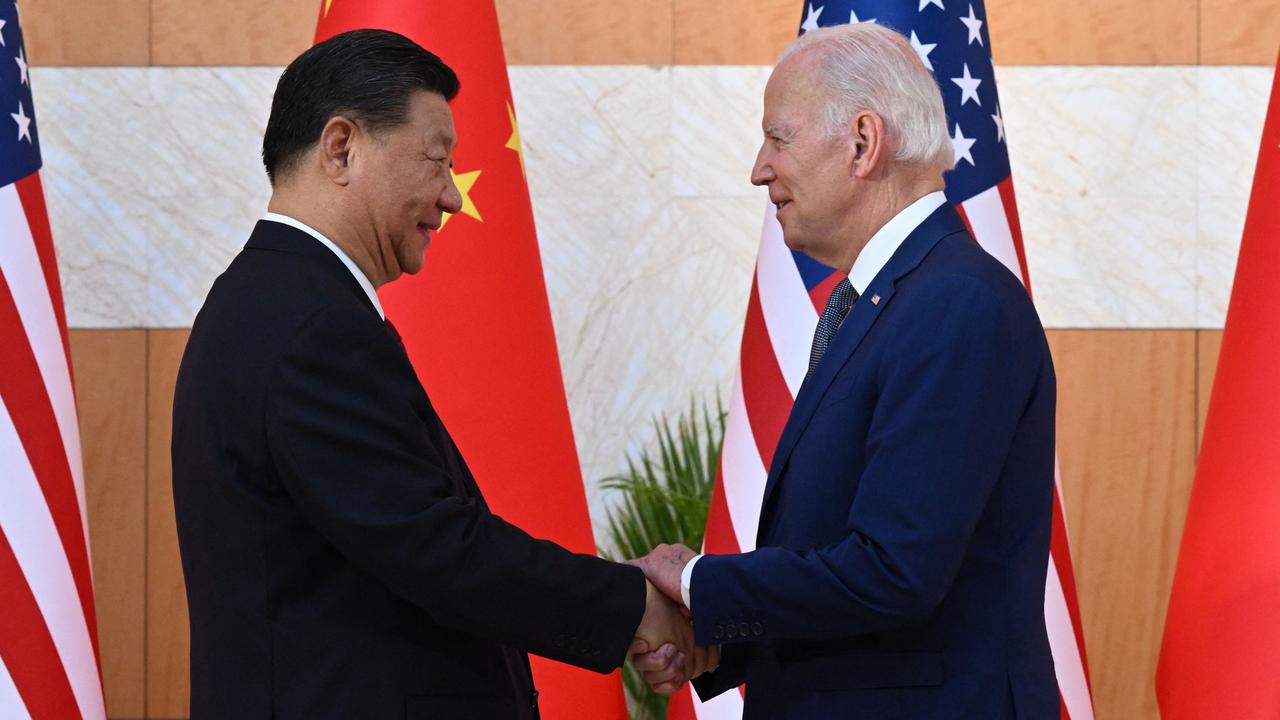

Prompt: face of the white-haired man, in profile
xmin=751 ymin=55 xmax=855 ymax=264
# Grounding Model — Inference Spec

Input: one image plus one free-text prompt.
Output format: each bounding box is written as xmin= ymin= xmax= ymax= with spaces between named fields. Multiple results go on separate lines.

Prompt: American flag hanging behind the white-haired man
xmin=671 ymin=0 xmax=1093 ymax=720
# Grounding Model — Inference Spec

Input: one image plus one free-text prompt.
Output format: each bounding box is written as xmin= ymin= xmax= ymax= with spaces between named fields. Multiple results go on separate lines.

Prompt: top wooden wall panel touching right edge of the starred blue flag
xmin=987 ymin=0 xmax=1203 ymax=65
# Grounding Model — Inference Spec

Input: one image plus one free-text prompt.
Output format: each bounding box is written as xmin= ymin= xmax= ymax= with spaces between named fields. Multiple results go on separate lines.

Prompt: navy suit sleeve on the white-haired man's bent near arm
xmin=690 ymin=277 xmax=1052 ymax=644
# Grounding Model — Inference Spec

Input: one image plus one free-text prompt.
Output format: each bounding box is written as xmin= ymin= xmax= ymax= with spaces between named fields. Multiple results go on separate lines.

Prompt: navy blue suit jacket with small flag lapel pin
xmin=690 ymin=205 xmax=1059 ymax=720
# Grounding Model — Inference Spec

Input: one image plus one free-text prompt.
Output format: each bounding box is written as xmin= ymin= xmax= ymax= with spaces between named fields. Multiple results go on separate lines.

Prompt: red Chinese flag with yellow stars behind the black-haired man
xmin=316 ymin=0 xmax=626 ymax=719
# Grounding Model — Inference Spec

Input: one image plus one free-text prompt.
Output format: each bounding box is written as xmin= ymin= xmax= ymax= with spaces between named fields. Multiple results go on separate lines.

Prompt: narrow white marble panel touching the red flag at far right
xmin=1194 ymin=68 xmax=1271 ymax=328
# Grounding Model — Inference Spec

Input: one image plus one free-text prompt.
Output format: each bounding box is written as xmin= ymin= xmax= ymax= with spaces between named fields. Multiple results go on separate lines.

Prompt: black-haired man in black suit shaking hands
xmin=173 ymin=31 xmax=691 ymax=719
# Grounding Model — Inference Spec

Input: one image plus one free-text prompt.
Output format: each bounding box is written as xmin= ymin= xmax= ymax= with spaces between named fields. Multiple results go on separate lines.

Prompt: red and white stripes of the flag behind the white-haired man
xmin=669 ymin=179 xmax=1093 ymax=720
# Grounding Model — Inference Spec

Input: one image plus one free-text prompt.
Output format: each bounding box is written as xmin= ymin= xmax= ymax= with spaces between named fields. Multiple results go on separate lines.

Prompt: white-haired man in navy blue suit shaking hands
xmin=637 ymin=23 xmax=1059 ymax=720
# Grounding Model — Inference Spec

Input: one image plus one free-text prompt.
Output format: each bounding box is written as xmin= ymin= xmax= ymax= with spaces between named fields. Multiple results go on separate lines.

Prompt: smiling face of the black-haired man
xmin=351 ymin=91 xmax=462 ymax=279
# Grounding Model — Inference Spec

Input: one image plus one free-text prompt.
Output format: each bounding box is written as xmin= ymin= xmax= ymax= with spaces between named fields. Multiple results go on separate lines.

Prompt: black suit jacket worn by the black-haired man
xmin=173 ymin=222 xmax=645 ymax=720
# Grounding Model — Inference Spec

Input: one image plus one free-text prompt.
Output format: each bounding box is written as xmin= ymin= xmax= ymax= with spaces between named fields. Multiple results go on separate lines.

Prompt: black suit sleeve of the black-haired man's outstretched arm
xmin=266 ymin=301 xmax=645 ymax=673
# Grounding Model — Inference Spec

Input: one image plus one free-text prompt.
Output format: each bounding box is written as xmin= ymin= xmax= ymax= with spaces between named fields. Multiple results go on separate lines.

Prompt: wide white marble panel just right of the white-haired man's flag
xmin=997 ymin=67 xmax=1197 ymax=328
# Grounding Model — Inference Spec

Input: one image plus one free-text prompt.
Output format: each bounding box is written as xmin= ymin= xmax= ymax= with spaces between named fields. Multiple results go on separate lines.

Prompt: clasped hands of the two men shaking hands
xmin=627 ymin=544 xmax=719 ymax=694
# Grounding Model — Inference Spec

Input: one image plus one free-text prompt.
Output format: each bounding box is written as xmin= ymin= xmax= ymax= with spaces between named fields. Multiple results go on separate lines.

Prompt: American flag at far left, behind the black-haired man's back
xmin=0 ymin=0 xmax=106 ymax=719
